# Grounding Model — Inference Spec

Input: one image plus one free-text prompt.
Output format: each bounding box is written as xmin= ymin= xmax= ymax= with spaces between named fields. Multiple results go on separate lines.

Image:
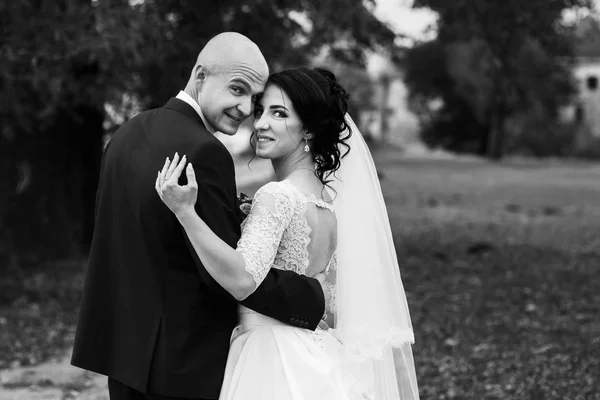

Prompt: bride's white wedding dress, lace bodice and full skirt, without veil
xmin=219 ymin=180 xmax=351 ymax=400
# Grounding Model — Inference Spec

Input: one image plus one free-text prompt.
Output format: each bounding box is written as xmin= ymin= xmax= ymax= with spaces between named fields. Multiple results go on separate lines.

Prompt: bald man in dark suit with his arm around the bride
xmin=71 ymin=32 xmax=325 ymax=400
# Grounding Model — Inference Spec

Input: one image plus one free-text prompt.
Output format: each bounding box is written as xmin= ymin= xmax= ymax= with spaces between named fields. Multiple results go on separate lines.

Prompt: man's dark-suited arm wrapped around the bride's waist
xmin=190 ymin=143 xmax=325 ymax=330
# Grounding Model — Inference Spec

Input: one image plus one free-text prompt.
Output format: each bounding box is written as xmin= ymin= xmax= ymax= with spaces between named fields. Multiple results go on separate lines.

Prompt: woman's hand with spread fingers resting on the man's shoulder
xmin=154 ymin=153 xmax=198 ymax=216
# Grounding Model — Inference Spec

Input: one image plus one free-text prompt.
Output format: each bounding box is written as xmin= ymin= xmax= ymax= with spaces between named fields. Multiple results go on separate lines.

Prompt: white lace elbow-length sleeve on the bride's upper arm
xmin=236 ymin=182 xmax=294 ymax=287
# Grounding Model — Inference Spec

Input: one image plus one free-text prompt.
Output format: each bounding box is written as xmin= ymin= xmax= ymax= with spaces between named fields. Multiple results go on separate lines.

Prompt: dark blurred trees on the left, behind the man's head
xmin=0 ymin=0 xmax=396 ymax=275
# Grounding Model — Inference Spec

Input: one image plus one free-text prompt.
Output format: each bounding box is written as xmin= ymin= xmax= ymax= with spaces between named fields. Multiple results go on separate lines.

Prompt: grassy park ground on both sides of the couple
xmin=0 ymin=147 xmax=600 ymax=400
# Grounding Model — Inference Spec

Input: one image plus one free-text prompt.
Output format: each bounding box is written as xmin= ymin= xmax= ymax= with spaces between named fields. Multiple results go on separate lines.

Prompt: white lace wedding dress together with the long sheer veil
xmin=220 ymin=115 xmax=419 ymax=400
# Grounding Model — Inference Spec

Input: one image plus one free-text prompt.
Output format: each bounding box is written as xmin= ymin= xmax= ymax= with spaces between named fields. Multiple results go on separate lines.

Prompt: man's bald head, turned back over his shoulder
xmin=185 ymin=32 xmax=269 ymax=135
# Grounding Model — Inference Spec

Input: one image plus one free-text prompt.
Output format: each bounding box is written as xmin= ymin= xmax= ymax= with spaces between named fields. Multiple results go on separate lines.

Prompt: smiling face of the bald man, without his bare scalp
xmin=198 ymin=61 xmax=268 ymax=135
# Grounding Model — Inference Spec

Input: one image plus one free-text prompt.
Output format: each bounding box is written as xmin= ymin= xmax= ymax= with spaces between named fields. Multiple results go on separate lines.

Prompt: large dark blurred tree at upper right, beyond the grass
xmin=403 ymin=0 xmax=594 ymax=159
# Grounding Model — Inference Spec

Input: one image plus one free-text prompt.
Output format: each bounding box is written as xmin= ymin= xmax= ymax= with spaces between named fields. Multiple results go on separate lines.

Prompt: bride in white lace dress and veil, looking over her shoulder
xmin=156 ymin=68 xmax=419 ymax=400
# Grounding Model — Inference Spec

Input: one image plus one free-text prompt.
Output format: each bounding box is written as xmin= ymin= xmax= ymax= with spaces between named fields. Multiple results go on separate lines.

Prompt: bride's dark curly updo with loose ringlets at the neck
xmin=267 ymin=68 xmax=352 ymax=185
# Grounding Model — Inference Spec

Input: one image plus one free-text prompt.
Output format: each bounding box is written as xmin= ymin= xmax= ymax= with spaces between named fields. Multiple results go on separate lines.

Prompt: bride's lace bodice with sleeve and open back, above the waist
xmin=237 ymin=180 xmax=337 ymax=284
